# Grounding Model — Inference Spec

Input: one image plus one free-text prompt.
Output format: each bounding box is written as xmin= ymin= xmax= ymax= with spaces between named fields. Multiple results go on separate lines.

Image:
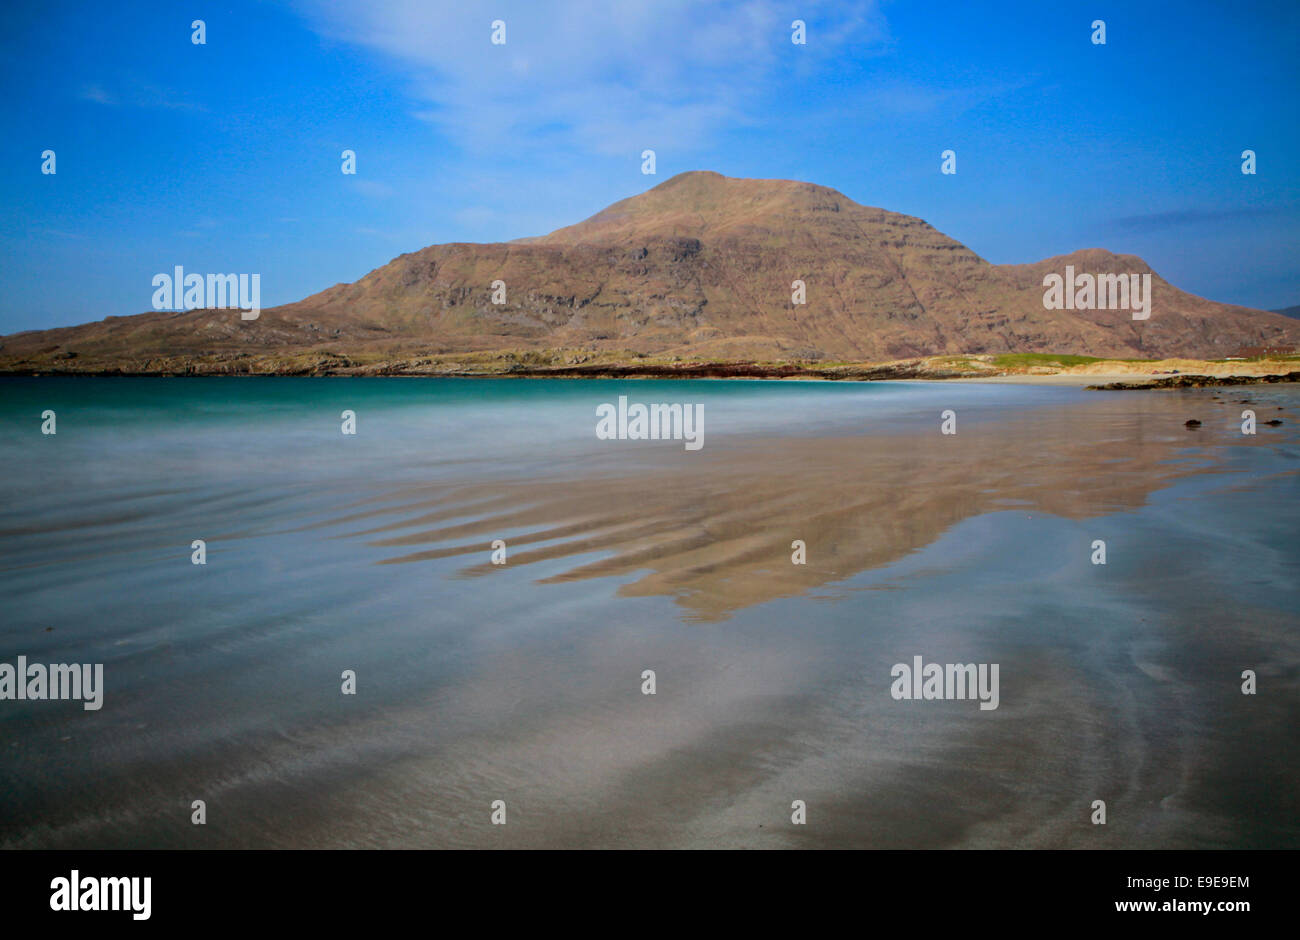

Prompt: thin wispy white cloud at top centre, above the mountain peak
xmin=299 ymin=0 xmax=885 ymax=156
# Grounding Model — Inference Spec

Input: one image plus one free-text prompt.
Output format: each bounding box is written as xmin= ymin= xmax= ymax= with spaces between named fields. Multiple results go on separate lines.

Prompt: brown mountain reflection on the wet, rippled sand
xmin=335 ymin=402 xmax=1251 ymax=620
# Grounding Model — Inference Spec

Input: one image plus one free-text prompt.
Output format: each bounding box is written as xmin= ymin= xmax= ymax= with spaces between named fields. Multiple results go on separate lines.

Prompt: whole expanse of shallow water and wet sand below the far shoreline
xmin=0 ymin=378 xmax=1300 ymax=848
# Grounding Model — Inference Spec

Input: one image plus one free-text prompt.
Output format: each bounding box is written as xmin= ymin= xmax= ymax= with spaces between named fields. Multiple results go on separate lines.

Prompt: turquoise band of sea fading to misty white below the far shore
xmin=0 ymin=377 xmax=1079 ymax=480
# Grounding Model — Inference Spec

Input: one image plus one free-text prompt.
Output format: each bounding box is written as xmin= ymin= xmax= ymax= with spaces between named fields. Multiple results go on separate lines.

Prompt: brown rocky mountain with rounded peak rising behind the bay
xmin=0 ymin=172 xmax=1300 ymax=372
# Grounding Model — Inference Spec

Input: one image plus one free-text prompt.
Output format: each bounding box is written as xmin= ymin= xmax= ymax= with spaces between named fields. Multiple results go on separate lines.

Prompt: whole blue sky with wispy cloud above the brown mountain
xmin=0 ymin=0 xmax=1300 ymax=333
